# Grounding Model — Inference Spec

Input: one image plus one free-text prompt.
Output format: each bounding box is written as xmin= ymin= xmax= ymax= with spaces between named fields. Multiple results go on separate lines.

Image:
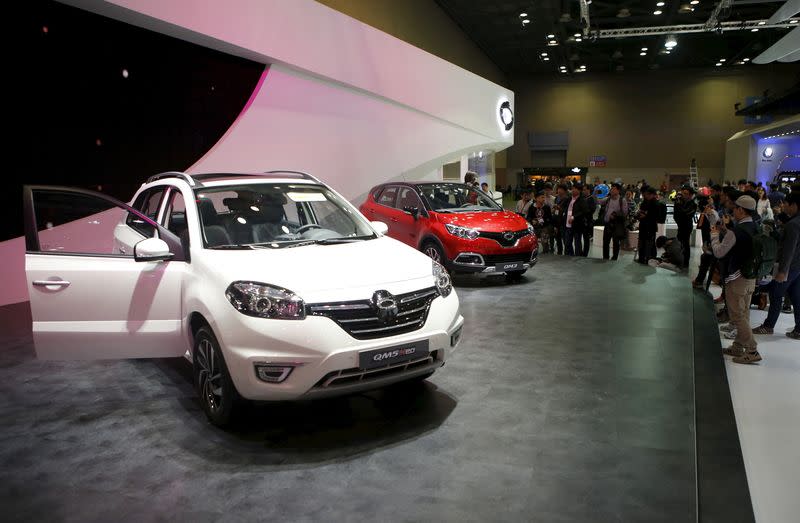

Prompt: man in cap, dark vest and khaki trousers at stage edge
xmin=711 ymin=195 xmax=761 ymax=363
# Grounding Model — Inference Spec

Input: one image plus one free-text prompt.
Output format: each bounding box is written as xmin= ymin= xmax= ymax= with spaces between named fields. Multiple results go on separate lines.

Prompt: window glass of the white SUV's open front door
xmin=32 ymin=190 xmax=132 ymax=257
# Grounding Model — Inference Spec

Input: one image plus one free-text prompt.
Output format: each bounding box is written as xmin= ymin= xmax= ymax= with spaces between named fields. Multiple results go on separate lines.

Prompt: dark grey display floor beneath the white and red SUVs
xmin=0 ymin=256 xmax=751 ymax=522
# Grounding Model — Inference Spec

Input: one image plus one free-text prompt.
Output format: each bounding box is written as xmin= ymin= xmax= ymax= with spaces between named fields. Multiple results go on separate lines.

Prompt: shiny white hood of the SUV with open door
xmin=203 ymin=237 xmax=434 ymax=302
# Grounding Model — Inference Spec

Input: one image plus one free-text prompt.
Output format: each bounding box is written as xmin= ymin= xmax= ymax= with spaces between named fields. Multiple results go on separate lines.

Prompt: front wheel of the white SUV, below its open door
xmin=192 ymin=326 xmax=242 ymax=427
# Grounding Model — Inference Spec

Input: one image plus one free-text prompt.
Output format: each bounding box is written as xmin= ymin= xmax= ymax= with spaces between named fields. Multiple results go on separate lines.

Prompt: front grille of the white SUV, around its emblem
xmin=306 ymin=287 xmax=438 ymax=340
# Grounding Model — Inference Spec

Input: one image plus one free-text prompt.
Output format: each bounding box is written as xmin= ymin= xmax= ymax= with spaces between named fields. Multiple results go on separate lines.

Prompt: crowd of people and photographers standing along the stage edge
xmin=504 ymin=175 xmax=800 ymax=363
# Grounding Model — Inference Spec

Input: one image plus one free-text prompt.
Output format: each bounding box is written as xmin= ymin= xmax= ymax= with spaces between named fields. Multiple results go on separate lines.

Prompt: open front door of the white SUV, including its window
xmin=23 ymin=186 xmax=186 ymax=360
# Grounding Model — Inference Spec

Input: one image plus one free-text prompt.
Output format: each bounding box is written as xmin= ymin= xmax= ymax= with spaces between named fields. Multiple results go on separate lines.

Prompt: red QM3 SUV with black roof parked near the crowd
xmin=361 ymin=182 xmax=539 ymax=279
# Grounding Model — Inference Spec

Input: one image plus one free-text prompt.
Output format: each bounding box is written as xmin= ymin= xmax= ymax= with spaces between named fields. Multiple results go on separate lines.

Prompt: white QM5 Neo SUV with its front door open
xmin=24 ymin=171 xmax=464 ymax=425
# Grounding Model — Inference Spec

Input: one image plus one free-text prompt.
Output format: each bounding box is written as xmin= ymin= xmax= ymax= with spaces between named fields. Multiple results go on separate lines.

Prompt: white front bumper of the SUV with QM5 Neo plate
xmin=219 ymin=292 xmax=464 ymax=401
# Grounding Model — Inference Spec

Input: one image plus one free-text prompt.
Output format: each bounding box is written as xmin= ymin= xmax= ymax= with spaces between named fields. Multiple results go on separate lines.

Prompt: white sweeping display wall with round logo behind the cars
xmin=0 ymin=0 xmax=514 ymax=305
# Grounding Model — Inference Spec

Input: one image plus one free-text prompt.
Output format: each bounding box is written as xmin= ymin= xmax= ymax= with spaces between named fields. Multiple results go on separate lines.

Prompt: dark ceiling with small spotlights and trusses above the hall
xmin=436 ymin=0 xmax=788 ymax=75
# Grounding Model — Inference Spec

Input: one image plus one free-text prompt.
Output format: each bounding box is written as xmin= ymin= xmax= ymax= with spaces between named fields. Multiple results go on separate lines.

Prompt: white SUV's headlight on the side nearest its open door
xmin=225 ymin=281 xmax=306 ymax=320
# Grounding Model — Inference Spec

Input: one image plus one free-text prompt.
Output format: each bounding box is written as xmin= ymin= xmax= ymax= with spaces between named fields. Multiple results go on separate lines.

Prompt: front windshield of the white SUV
xmin=195 ymin=184 xmax=376 ymax=249
